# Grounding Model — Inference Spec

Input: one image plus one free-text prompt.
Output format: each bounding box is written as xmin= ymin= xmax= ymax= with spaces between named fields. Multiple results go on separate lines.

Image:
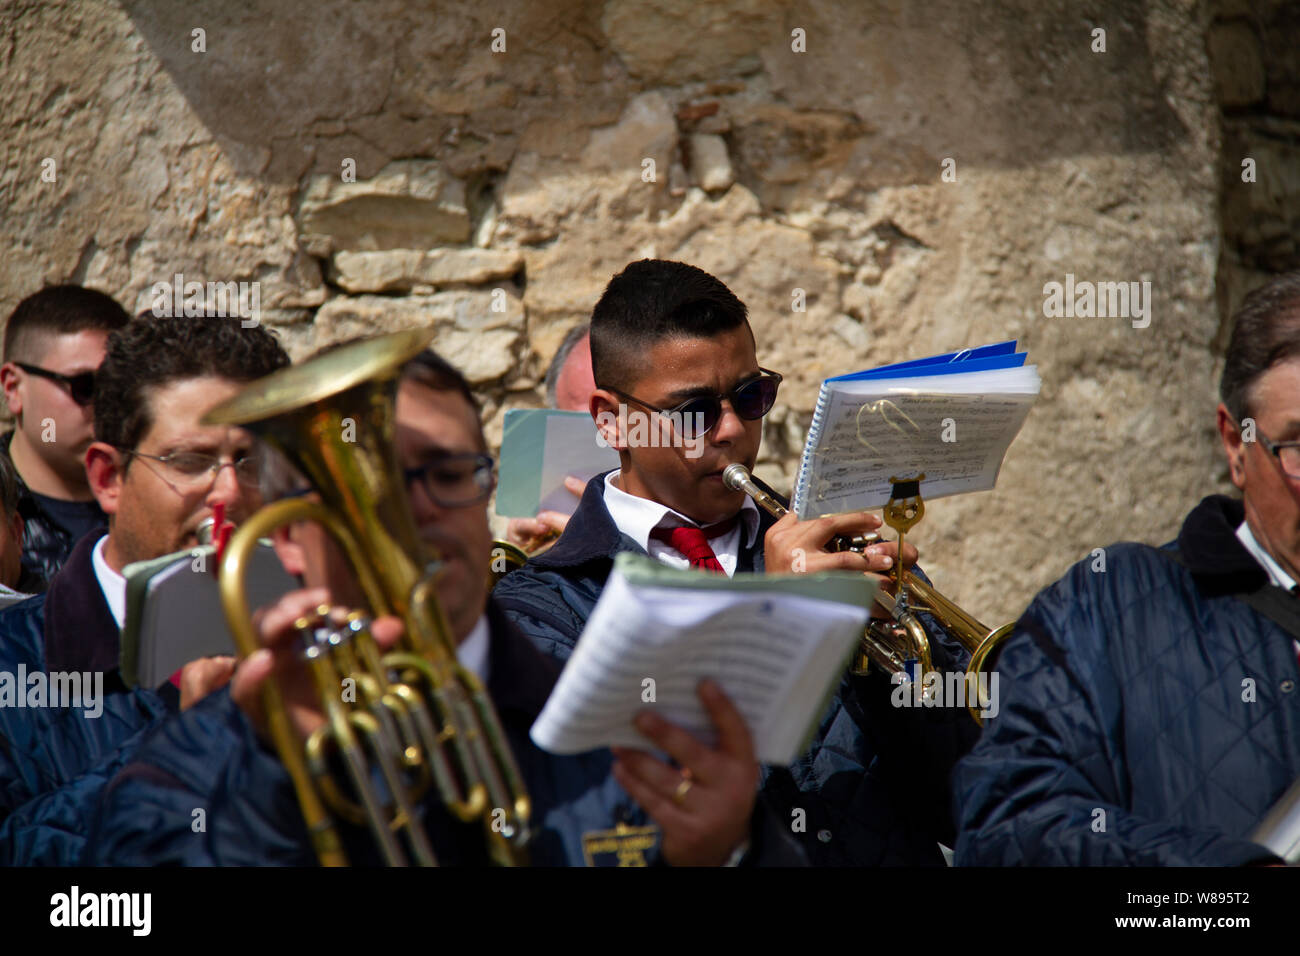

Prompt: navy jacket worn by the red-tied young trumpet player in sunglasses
xmin=493 ymin=475 xmax=978 ymax=865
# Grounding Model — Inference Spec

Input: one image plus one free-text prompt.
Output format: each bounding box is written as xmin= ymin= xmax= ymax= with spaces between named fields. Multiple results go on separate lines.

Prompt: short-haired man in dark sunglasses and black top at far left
xmin=0 ymin=285 xmax=130 ymax=591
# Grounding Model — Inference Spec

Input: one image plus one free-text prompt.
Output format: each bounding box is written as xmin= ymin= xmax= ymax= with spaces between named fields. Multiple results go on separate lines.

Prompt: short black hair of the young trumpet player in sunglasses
xmin=592 ymin=259 xmax=749 ymax=389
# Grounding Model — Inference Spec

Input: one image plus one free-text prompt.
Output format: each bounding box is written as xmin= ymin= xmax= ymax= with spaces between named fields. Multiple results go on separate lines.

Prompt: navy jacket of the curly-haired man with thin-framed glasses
xmin=0 ymin=535 xmax=177 ymax=865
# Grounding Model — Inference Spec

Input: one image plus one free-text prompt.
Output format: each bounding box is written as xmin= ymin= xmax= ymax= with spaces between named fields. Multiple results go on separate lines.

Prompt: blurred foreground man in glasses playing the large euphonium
xmin=88 ymin=352 xmax=802 ymax=865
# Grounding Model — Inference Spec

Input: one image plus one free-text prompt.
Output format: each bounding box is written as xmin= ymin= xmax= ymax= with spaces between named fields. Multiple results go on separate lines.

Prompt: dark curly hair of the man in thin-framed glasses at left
xmin=95 ymin=316 xmax=289 ymax=464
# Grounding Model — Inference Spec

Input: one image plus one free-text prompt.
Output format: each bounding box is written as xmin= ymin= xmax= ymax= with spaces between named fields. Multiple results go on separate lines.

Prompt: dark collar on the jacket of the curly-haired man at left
xmin=46 ymin=532 xmax=121 ymax=674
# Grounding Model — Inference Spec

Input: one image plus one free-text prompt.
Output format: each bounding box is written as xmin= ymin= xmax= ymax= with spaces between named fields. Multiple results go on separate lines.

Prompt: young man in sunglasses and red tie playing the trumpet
xmin=494 ymin=260 xmax=975 ymax=865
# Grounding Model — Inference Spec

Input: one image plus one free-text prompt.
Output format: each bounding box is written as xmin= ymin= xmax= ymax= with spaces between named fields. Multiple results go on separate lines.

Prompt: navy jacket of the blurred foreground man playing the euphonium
xmin=87 ymin=604 xmax=798 ymax=866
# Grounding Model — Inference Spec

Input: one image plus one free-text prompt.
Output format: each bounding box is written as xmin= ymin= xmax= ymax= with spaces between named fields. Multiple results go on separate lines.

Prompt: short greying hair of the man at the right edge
xmin=1219 ymin=272 xmax=1300 ymax=423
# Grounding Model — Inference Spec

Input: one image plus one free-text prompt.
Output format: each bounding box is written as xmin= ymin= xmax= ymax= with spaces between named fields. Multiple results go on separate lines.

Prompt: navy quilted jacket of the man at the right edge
xmin=954 ymin=496 xmax=1300 ymax=866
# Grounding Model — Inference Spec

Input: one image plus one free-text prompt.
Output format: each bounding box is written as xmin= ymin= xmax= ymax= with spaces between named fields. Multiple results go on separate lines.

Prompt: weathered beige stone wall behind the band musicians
xmin=0 ymin=0 xmax=1284 ymax=622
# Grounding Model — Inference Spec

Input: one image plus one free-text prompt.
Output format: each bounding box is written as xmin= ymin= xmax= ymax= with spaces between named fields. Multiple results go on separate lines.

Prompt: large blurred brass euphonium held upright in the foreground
xmin=204 ymin=330 xmax=530 ymax=866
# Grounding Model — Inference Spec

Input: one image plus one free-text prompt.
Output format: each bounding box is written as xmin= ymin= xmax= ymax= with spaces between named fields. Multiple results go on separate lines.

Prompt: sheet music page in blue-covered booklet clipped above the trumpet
xmin=794 ymin=365 xmax=1039 ymax=520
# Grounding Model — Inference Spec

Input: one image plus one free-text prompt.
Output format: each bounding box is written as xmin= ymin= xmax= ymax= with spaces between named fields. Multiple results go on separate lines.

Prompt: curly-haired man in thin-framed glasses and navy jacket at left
xmin=0 ymin=317 xmax=289 ymax=864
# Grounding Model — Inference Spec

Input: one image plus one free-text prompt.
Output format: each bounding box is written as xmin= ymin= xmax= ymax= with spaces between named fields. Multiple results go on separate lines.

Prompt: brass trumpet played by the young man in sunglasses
xmin=723 ymin=464 xmax=1015 ymax=723
